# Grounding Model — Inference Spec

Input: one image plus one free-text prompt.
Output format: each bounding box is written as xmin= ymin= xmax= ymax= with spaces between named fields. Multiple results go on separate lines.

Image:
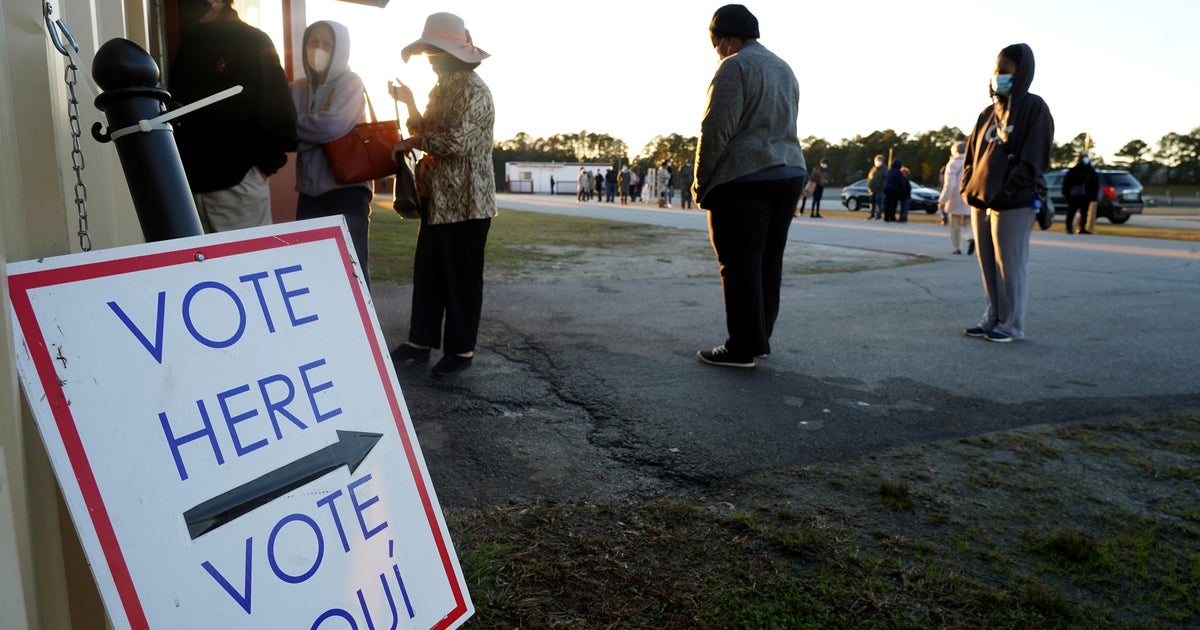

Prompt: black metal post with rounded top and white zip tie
xmin=91 ymin=38 xmax=204 ymax=242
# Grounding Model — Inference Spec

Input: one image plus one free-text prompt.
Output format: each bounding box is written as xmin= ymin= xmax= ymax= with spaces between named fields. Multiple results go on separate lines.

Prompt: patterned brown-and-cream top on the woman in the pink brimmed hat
xmin=408 ymin=71 xmax=496 ymax=224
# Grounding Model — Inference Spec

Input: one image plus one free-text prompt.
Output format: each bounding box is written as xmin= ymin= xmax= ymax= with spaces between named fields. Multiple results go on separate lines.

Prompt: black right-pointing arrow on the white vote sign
xmin=184 ymin=431 xmax=383 ymax=540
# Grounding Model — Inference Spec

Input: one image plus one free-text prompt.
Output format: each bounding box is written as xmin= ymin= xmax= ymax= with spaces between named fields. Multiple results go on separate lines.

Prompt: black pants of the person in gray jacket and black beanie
xmin=703 ymin=178 xmax=804 ymax=356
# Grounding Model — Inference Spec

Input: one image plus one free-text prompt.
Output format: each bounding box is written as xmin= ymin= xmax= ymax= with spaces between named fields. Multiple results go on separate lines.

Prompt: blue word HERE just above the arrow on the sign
xmin=158 ymin=359 xmax=342 ymax=481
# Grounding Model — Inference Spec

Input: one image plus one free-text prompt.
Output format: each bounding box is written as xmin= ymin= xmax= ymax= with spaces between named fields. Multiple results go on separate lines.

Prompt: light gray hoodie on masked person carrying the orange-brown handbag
xmin=292 ymin=22 xmax=371 ymax=197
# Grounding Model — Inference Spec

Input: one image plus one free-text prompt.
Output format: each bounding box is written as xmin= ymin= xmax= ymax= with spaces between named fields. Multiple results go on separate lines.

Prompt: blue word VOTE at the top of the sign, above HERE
xmin=106 ymin=265 xmax=320 ymax=365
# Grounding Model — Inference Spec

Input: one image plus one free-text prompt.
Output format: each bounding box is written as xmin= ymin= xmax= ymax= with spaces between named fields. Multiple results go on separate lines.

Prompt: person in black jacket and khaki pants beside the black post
xmin=167 ymin=0 xmax=296 ymax=234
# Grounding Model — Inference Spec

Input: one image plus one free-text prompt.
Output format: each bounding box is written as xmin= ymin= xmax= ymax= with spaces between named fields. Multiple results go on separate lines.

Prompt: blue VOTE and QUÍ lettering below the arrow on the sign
xmin=200 ymin=473 xmax=415 ymax=630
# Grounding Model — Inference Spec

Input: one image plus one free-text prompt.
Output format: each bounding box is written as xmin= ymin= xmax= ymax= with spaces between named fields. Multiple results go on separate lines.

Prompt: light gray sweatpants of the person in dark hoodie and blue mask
xmin=971 ymin=208 xmax=1037 ymax=340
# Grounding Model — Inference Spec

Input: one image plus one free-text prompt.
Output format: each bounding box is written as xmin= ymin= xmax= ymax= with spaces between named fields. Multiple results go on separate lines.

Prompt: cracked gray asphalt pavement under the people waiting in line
xmin=376 ymin=196 xmax=1200 ymax=505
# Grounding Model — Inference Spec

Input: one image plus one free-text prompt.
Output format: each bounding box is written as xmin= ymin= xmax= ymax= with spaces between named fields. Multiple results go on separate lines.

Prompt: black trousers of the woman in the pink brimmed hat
xmin=408 ymin=218 xmax=492 ymax=354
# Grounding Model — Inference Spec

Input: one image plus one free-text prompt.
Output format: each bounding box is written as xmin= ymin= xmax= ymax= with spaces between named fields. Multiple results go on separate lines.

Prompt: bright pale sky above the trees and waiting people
xmin=292 ymin=0 xmax=1200 ymax=157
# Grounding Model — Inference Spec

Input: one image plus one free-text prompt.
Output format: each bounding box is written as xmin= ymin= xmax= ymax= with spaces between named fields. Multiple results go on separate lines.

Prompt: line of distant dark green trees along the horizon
xmin=493 ymin=127 xmax=1200 ymax=190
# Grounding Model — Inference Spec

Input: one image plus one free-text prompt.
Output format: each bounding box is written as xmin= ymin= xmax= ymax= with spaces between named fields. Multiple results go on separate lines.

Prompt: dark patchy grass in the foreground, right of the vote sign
xmin=448 ymin=418 xmax=1200 ymax=630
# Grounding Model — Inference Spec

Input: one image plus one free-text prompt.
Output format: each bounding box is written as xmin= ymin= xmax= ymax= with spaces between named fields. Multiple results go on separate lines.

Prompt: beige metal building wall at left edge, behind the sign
xmin=0 ymin=0 xmax=154 ymax=630
